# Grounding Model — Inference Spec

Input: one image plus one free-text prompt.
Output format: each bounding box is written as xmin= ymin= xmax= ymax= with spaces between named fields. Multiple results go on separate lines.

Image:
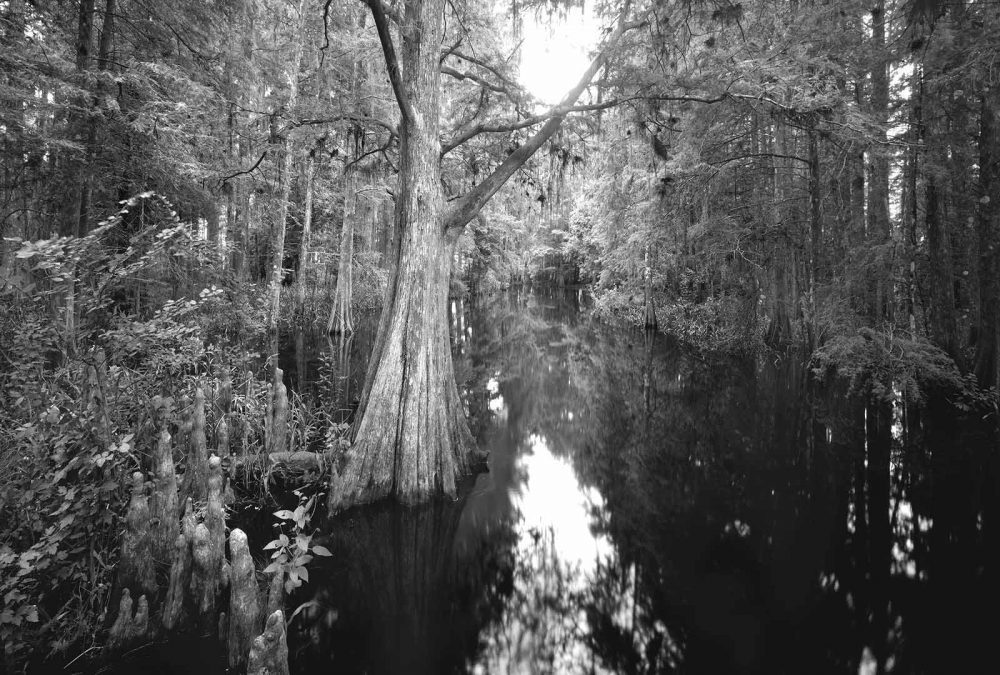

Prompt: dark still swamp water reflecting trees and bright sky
xmin=278 ymin=295 xmax=1000 ymax=673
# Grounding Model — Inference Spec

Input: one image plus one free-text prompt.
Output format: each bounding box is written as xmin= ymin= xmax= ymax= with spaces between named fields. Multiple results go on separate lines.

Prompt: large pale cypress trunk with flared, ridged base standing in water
xmin=330 ymin=0 xmax=472 ymax=511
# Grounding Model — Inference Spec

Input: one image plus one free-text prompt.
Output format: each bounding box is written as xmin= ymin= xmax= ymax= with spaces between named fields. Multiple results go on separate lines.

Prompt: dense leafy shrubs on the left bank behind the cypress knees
xmin=0 ymin=195 xmax=278 ymax=663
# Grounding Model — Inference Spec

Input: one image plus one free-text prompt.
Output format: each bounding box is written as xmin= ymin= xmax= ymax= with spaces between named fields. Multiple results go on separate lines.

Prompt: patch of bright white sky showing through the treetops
xmin=521 ymin=3 xmax=600 ymax=104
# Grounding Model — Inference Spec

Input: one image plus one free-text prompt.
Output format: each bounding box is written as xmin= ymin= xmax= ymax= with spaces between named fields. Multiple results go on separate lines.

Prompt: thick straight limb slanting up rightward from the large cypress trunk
xmin=444 ymin=0 xmax=638 ymax=232
